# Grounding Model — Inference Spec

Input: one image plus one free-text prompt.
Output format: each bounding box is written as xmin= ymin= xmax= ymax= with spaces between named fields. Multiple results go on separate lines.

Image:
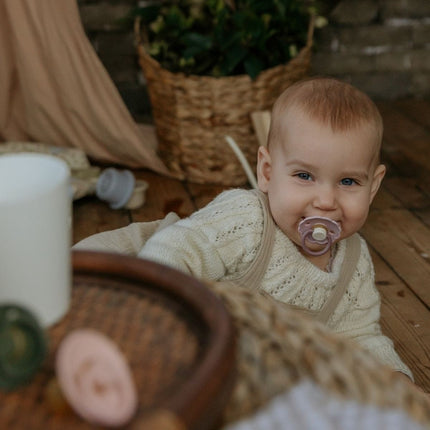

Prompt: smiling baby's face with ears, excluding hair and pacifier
xmin=257 ymin=114 xmax=385 ymax=255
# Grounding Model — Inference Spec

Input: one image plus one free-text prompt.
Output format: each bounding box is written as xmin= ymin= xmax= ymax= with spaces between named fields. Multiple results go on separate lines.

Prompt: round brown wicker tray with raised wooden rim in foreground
xmin=0 ymin=251 xmax=235 ymax=430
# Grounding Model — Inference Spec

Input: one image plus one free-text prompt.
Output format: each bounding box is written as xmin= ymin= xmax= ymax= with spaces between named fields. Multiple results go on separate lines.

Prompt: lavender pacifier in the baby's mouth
xmin=298 ymin=216 xmax=341 ymax=255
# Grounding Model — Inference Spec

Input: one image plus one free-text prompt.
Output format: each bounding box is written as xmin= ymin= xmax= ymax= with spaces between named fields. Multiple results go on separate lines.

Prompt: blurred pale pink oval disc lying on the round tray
xmin=56 ymin=329 xmax=137 ymax=427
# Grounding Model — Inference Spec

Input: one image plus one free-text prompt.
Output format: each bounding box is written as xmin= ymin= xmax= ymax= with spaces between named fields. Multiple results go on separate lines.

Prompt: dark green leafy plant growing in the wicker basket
xmin=131 ymin=0 xmax=322 ymax=78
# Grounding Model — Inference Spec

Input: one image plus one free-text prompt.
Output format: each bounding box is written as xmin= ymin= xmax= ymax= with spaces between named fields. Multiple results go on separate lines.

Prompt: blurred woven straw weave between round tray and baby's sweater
xmin=207 ymin=282 xmax=430 ymax=429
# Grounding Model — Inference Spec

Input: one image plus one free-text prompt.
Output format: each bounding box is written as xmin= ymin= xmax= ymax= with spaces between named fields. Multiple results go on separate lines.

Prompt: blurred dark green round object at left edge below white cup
xmin=0 ymin=304 xmax=47 ymax=391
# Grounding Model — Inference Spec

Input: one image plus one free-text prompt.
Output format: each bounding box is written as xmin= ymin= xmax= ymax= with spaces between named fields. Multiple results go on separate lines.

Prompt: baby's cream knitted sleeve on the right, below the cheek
xmin=329 ymin=238 xmax=413 ymax=380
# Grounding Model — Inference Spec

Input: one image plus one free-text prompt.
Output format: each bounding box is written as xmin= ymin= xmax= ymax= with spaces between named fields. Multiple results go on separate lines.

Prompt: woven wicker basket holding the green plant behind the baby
xmin=135 ymin=19 xmax=314 ymax=186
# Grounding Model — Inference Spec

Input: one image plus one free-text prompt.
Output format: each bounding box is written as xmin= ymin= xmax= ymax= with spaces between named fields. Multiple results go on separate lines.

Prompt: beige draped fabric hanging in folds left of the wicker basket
xmin=0 ymin=0 xmax=167 ymax=173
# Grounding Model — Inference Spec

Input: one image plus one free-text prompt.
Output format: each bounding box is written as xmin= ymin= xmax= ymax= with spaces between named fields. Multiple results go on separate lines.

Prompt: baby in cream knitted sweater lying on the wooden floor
xmin=139 ymin=78 xmax=412 ymax=378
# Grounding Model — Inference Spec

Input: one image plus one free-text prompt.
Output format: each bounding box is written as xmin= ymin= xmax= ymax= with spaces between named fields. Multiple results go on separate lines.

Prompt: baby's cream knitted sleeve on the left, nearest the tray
xmin=138 ymin=189 xmax=263 ymax=280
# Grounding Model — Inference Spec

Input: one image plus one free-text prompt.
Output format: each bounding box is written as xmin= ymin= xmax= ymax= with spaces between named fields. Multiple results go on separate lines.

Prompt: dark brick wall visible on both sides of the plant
xmin=78 ymin=0 xmax=430 ymax=117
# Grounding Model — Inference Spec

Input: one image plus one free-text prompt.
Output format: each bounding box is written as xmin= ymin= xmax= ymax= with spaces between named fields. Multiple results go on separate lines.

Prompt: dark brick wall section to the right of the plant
xmin=313 ymin=0 xmax=430 ymax=99
